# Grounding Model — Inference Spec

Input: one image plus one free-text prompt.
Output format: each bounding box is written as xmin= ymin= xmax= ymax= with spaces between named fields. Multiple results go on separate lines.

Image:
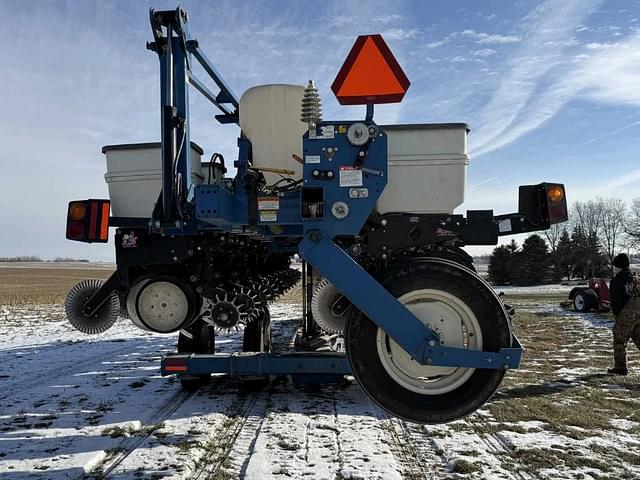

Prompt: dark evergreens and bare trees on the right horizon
xmin=489 ymin=198 xmax=640 ymax=285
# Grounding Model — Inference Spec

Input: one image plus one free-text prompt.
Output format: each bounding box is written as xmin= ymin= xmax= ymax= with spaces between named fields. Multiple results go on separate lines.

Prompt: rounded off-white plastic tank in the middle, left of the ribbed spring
xmin=239 ymin=84 xmax=307 ymax=184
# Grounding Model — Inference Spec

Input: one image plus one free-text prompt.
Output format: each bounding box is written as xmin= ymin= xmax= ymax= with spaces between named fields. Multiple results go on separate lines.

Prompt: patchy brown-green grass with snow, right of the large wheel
xmin=470 ymin=295 xmax=640 ymax=478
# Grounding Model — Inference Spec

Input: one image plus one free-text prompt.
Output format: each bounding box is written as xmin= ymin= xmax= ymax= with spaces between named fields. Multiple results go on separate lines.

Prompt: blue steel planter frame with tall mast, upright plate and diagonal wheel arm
xmin=151 ymin=8 xmax=522 ymax=374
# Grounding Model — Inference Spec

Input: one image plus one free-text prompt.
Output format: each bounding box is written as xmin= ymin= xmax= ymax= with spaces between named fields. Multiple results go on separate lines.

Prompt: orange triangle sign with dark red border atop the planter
xmin=331 ymin=35 xmax=411 ymax=105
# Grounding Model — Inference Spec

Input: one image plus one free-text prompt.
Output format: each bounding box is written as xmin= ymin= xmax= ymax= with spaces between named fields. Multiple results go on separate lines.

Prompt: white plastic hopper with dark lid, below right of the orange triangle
xmin=376 ymin=123 xmax=469 ymax=214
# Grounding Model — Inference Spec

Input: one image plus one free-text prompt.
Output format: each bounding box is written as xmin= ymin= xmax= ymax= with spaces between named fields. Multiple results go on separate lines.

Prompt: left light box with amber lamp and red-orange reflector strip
xmin=67 ymin=200 xmax=111 ymax=243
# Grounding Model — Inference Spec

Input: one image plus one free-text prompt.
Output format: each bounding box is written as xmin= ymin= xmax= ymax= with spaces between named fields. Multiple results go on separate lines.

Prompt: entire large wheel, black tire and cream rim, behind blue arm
xmin=346 ymin=260 xmax=511 ymax=423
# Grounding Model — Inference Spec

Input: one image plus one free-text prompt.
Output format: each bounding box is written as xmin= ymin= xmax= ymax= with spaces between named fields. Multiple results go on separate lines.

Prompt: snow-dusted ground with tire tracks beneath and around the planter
xmin=0 ymin=289 xmax=640 ymax=479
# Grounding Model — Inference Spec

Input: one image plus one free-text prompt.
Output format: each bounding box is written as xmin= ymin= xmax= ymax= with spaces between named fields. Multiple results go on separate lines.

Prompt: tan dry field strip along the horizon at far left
xmin=0 ymin=266 xmax=113 ymax=305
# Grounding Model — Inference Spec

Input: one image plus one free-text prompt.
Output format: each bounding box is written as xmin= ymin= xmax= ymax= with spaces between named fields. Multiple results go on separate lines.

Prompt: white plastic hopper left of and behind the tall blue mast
xmin=102 ymin=142 xmax=204 ymax=218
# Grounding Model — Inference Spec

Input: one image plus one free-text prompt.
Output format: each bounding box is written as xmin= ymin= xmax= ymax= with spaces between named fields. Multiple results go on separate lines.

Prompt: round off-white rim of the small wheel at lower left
xmin=136 ymin=281 xmax=189 ymax=332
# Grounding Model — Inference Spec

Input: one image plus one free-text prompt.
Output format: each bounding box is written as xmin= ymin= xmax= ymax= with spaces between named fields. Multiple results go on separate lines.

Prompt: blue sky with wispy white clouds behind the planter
xmin=0 ymin=0 xmax=640 ymax=260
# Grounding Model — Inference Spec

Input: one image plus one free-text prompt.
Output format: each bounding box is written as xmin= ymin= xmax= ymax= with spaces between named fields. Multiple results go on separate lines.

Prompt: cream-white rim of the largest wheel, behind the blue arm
xmin=376 ymin=289 xmax=482 ymax=395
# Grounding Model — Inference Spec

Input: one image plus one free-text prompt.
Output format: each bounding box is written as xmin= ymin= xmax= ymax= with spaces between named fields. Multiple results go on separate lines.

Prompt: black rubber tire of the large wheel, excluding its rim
xmin=346 ymin=259 xmax=512 ymax=424
